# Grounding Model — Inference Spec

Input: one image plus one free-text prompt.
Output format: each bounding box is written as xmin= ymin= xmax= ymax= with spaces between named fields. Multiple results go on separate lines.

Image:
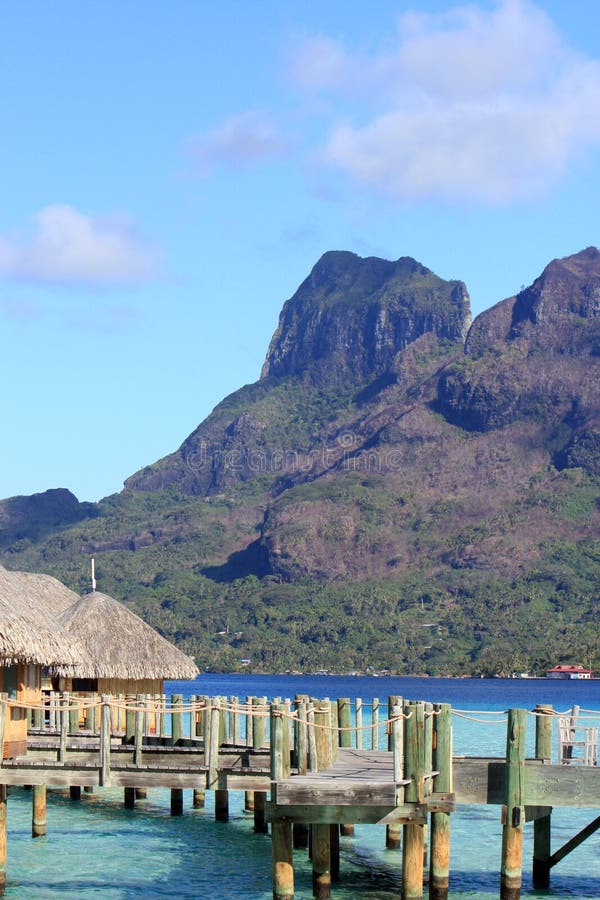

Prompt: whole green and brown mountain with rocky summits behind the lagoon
xmin=0 ymin=248 xmax=600 ymax=674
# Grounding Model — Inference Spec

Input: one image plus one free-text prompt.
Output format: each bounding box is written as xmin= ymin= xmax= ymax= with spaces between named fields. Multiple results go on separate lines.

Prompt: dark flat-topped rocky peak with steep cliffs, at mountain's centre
xmin=261 ymin=251 xmax=470 ymax=385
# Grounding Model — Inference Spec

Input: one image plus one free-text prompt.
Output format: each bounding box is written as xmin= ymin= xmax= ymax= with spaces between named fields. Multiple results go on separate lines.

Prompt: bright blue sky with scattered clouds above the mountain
xmin=0 ymin=0 xmax=600 ymax=500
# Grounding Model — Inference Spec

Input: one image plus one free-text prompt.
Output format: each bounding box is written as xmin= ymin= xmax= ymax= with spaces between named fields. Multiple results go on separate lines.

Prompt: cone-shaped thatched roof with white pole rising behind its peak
xmin=57 ymin=591 xmax=198 ymax=680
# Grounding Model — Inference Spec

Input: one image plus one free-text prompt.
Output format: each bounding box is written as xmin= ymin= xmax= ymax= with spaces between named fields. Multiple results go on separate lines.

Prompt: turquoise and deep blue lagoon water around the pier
xmin=6 ymin=675 xmax=600 ymax=900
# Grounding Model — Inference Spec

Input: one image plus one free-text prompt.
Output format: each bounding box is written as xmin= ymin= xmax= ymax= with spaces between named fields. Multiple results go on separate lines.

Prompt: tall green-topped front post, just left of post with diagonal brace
xmin=500 ymin=709 xmax=527 ymax=900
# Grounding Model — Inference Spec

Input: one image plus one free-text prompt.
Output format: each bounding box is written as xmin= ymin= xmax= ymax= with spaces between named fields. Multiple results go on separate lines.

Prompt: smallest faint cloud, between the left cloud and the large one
xmin=190 ymin=110 xmax=286 ymax=172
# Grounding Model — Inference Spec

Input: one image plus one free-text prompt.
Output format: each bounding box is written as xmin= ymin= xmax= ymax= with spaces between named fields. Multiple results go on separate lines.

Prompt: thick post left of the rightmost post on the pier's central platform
xmin=402 ymin=703 xmax=425 ymax=900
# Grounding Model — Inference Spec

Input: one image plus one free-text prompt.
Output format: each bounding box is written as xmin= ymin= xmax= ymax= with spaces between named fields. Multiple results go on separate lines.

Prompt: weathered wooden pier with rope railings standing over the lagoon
xmin=0 ymin=694 xmax=600 ymax=900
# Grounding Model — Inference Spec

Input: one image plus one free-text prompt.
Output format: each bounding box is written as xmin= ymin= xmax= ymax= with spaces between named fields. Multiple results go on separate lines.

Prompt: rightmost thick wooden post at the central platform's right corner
xmin=429 ymin=703 xmax=452 ymax=900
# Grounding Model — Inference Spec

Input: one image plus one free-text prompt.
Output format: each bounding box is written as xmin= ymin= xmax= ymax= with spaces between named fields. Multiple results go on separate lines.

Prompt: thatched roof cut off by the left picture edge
xmin=0 ymin=566 xmax=82 ymax=666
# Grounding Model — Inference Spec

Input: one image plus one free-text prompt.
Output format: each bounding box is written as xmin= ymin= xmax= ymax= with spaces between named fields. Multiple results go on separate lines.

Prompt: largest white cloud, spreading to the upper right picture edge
xmin=292 ymin=0 xmax=600 ymax=203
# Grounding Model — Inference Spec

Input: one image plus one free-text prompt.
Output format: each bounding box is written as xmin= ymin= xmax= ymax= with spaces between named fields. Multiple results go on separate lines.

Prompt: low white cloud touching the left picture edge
xmin=0 ymin=204 xmax=156 ymax=285
